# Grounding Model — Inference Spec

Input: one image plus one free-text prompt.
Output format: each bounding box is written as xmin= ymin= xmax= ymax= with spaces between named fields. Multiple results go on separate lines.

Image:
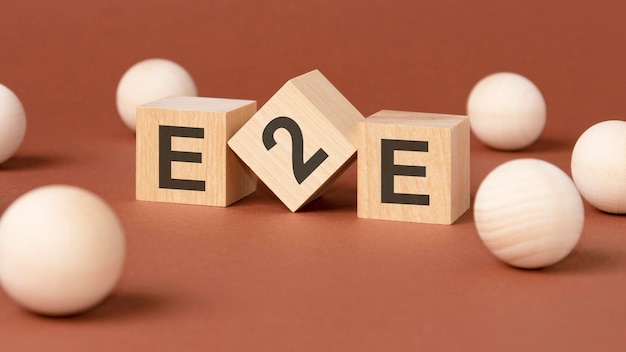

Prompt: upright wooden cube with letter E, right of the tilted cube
xmin=357 ymin=110 xmax=470 ymax=225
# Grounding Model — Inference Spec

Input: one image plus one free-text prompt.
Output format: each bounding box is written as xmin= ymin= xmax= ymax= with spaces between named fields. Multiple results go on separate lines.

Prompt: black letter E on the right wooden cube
xmin=380 ymin=139 xmax=430 ymax=205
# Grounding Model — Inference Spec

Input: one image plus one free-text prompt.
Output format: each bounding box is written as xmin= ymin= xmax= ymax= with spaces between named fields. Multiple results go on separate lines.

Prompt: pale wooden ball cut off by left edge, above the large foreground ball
xmin=0 ymin=84 xmax=26 ymax=164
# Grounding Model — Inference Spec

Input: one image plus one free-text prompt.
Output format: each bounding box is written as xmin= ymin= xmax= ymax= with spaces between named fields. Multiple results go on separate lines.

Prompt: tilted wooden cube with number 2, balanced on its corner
xmin=228 ymin=70 xmax=364 ymax=212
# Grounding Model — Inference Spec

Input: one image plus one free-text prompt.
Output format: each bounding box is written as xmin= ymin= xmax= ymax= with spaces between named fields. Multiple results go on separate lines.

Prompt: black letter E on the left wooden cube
xmin=159 ymin=126 xmax=205 ymax=191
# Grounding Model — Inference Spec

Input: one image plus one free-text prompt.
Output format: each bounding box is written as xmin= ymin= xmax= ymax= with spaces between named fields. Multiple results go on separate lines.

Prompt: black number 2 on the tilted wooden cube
xmin=263 ymin=116 xmax=328 ymax=184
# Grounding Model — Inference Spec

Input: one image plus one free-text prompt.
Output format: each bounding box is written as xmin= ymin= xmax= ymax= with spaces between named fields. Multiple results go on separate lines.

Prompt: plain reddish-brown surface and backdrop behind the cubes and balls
xmin=0 ymin=0 xmax=626 ymax=351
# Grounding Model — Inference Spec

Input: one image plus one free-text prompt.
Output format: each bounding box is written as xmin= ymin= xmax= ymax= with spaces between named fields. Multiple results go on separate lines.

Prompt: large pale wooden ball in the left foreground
xmin=0 ymin=185 xmax=126 ymax=315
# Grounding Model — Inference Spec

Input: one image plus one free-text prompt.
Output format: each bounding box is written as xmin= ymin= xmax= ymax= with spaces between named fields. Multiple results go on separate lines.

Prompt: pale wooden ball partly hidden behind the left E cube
xmin=116 ymin=58 xmax=198 ymax=131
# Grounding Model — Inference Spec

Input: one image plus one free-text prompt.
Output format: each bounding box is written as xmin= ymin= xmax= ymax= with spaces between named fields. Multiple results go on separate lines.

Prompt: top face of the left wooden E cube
xmin=139 ymin=96 xmax=256 ymax=113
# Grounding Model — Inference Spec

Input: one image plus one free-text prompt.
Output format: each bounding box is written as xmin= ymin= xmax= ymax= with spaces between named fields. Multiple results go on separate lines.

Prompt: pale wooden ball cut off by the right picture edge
xmin=572 ymin=120 xmax=626 ymax=214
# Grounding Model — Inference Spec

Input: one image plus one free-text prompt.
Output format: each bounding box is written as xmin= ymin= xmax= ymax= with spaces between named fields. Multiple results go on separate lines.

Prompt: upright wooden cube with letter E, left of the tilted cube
xmin=136 ymin=97 xmax=257 ymax=207
